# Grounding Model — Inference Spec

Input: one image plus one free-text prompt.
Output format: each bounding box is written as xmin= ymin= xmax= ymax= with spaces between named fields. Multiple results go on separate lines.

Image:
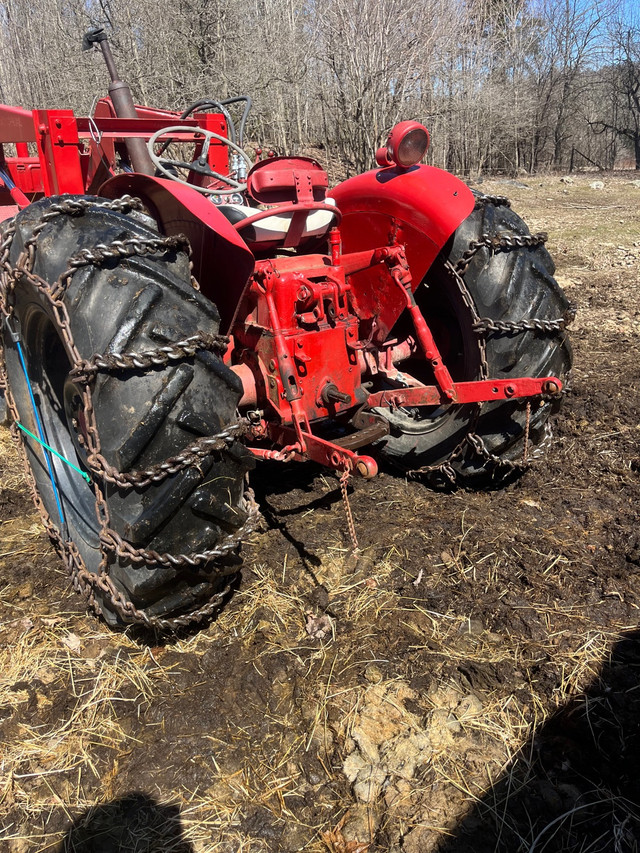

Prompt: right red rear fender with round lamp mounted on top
xmin=329 ymin=166 xmax=475 ymax=345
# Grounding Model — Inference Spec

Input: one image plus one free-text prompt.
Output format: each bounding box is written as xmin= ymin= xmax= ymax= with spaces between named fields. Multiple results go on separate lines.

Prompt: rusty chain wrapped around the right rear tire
xmin=408 ymin=195 xmax=576 ymax=486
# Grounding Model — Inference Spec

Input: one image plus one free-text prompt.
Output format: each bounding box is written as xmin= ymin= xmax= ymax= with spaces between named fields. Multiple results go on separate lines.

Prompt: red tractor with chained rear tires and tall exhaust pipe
xmin=0 ymin=28 xmax=572 ymax=630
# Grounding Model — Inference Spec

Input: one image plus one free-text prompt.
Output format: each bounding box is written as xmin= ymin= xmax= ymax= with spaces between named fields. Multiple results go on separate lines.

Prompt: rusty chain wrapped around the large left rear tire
xmin=0 ymin=196 xmax=261 ymax=631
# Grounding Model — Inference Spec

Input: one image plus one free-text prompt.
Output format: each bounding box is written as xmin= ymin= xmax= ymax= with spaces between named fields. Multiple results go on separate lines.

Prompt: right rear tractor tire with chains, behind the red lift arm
xmin=380 ymin=195 xmax=574 ymax=486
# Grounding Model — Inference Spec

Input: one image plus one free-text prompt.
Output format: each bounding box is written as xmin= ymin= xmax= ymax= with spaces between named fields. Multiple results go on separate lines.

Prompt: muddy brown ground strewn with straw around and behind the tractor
xmin=0 ymin=173 xmax=640 ymax=853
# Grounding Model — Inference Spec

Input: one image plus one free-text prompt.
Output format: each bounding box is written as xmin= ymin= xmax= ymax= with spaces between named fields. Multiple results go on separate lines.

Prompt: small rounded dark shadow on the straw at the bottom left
xmin=56 ymin=793 xmax=195 ymax=853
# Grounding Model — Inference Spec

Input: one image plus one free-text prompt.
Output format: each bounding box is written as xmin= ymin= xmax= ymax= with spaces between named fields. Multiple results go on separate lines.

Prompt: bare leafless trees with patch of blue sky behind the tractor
xmin=0 ymin=0 xmax=640 ymax=175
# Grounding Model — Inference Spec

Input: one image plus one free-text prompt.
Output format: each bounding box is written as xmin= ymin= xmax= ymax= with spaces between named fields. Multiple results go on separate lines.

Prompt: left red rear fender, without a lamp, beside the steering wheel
xmin=99 ymin=172 xmax=255 ymax=332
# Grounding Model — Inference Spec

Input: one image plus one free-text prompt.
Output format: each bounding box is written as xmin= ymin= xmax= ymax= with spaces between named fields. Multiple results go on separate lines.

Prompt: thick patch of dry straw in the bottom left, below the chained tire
xmin=0 ymin=612 xmax=167 ymax=842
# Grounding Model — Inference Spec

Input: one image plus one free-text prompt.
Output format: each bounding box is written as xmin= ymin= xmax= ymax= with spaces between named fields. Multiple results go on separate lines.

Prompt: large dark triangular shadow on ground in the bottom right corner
xmin=437 ymin=631 xmax=640 ymax=853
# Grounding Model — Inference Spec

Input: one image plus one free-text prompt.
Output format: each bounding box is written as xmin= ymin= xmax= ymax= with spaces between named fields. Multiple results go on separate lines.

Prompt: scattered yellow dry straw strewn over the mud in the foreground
xmin=0 ymin=490 xmax=636 ymax=853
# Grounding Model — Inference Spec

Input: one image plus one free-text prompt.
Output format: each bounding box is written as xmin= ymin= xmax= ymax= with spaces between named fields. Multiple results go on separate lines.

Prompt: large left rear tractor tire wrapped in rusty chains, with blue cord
xmin=0 ymin=196 xmax=257 ymax=630
